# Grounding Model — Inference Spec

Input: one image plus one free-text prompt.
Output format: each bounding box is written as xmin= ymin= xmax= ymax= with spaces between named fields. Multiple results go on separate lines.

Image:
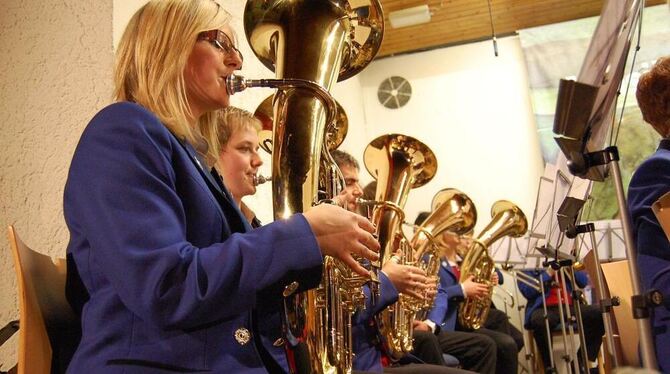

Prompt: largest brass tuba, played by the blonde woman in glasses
xmin=236 ymin=0 xmax=384 ymax=373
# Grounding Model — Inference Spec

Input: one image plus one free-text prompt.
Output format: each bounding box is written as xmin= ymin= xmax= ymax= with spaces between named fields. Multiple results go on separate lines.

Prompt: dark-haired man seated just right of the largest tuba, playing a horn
xmin=331 ymin=150 xmax=472 ymax=374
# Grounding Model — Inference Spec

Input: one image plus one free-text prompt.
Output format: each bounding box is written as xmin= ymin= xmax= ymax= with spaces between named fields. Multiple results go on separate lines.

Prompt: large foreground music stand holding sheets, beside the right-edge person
xmin=554 ymin=0 xmax=658 ymax=369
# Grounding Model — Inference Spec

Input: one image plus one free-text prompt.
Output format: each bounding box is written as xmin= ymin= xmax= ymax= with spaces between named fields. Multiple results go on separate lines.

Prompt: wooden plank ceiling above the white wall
xmin=378 ymin=0 xmax=667 ymax=57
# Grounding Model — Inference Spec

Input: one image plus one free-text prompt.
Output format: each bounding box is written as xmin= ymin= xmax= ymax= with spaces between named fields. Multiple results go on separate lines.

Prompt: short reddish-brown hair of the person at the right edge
xmin=635 ymin=57 xmax=670 ymax=137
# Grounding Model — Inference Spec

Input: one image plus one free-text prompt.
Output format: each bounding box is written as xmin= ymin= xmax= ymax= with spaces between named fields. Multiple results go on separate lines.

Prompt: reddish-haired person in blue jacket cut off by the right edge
xmin=628 ymin=56 xmax=670 ymax=372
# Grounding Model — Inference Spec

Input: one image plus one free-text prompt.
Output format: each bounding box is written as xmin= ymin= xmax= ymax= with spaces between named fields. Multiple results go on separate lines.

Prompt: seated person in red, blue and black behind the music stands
xmin=518 ymin=267 xmax=605 ymax=372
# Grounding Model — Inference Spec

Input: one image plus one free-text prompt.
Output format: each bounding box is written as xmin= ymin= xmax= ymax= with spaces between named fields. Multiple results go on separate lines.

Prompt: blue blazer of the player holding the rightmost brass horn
xmin=428 ymin=259 xmax=464 ymax=331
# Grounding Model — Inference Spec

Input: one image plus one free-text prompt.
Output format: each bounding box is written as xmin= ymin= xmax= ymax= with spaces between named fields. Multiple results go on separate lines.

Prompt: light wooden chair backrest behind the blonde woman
xmin=8 ymin=226 xmax=76 ymax=374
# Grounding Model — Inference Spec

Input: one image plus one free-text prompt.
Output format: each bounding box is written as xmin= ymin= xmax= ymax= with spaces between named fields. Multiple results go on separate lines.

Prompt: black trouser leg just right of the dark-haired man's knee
xmin=437 ymin=331 xmax=496 ymax=374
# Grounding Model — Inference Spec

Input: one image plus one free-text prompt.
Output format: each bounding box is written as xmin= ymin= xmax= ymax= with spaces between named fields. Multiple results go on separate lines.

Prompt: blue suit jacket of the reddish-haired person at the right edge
xmin=628 ymin=139 xmax=670 ymax=371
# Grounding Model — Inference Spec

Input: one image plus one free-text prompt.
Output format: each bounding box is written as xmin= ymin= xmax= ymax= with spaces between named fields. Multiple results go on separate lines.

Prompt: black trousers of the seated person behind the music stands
xmin=529 ymin=305 xmax=605 ymax=368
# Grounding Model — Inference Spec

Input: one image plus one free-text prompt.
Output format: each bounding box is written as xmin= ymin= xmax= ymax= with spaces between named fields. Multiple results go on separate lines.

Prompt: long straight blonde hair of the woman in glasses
xmin=114 ymin=0 xmax=230 ymax=163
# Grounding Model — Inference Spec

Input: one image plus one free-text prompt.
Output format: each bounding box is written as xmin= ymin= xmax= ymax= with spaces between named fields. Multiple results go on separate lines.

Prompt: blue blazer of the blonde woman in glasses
xmin=64 ymin=103 xmax=322 ymax=373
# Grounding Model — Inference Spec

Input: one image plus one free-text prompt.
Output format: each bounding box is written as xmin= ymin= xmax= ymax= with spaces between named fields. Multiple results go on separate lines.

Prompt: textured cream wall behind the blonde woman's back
xmin=0 ymin=0 xmax=113 ymax=364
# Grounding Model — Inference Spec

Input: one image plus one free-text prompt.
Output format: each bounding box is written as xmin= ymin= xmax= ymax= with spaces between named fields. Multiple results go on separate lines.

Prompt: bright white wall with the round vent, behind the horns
xmin=335 ymin=37 xmax=543 ymax=234
